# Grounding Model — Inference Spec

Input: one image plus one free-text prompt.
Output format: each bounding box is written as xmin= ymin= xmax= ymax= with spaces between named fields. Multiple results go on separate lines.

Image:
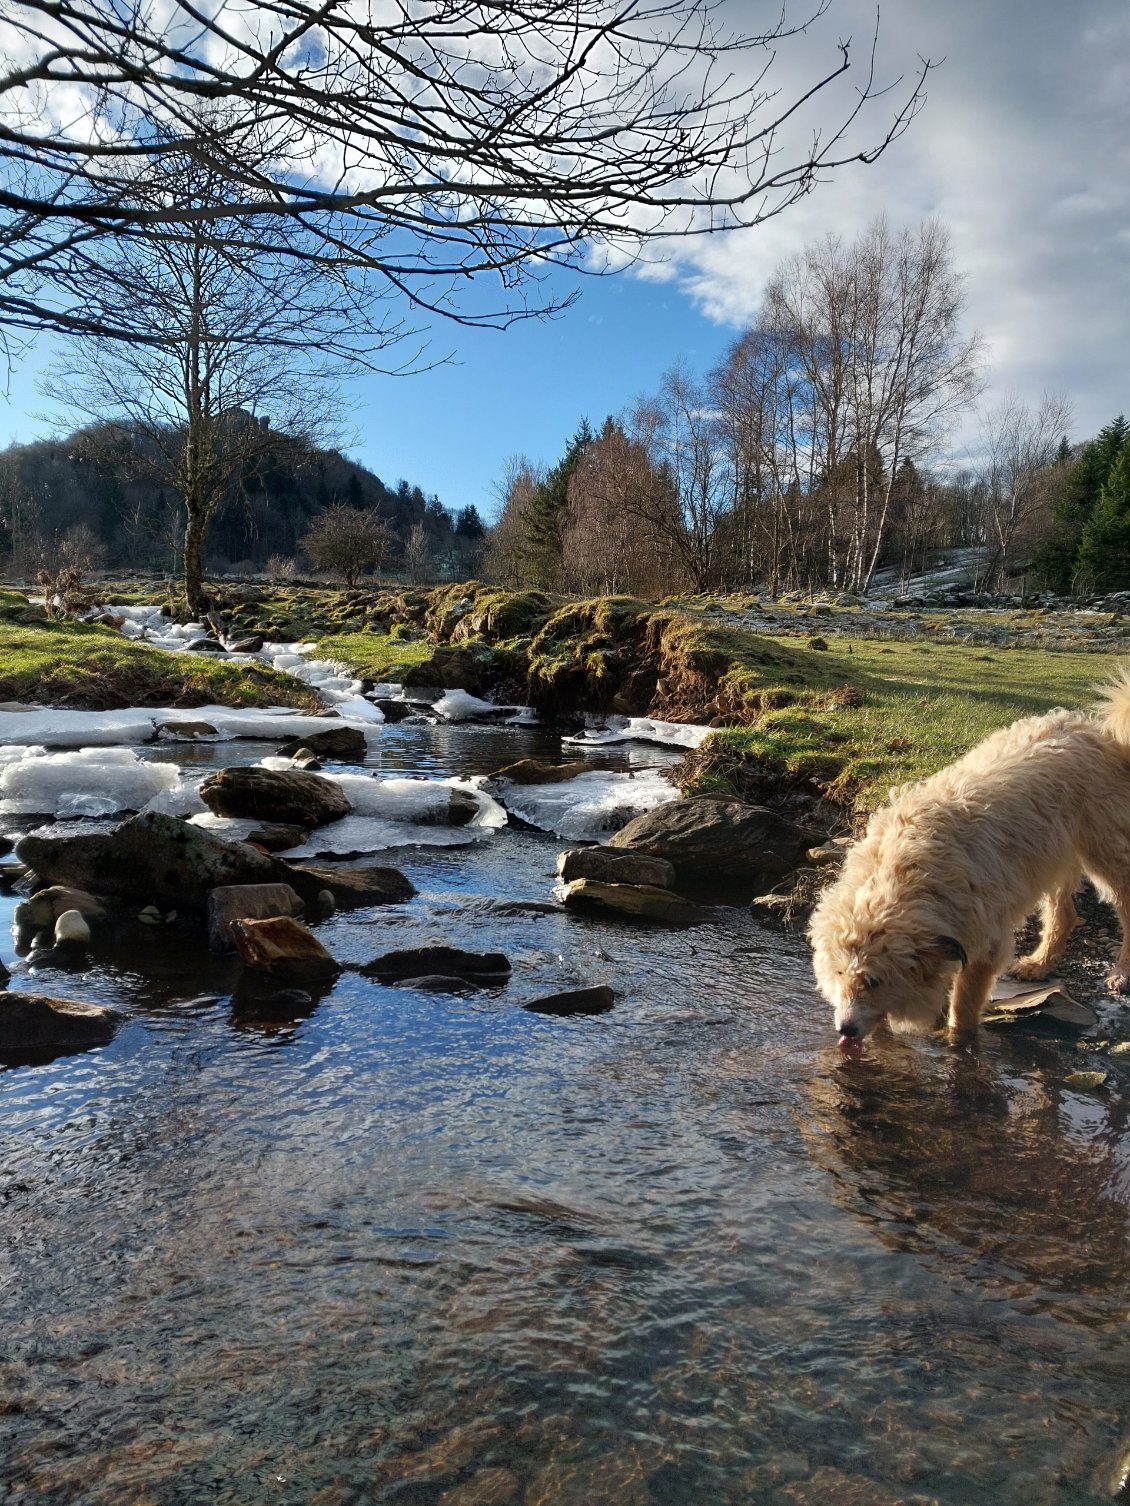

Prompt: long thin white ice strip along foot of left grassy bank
xmin=0 ymin=702 xmax=380 ymax=748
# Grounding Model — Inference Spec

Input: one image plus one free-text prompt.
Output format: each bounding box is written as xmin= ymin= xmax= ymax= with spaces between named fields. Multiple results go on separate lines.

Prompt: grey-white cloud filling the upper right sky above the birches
xmin=644 ymin=0 xmax=1130 ymax=437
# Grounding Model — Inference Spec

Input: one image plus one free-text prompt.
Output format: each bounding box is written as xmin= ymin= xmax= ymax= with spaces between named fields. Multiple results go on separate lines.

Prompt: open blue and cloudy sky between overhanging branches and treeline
xmin=0 ymin=0 xmax=1130 ymax=515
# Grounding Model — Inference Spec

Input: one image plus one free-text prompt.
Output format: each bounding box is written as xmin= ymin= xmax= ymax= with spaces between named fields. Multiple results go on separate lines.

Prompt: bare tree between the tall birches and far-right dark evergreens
xmin=982 ymin=393 xmax=1071 ymax=584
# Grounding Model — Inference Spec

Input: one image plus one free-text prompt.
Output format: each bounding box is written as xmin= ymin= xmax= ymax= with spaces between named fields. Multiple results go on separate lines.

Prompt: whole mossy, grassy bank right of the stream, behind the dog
xmin=99 ymin=581 xmax=1122 ymax=812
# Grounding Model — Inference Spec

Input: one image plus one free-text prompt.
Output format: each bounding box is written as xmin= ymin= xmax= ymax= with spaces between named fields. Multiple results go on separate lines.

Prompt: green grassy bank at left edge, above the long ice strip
xmin=0 ymin=592 xmax=318 ymax=711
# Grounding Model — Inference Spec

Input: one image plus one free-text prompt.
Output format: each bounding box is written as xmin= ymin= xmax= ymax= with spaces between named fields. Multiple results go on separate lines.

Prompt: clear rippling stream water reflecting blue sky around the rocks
xmin=0 ymin=726 xmax=1130 ymax=1506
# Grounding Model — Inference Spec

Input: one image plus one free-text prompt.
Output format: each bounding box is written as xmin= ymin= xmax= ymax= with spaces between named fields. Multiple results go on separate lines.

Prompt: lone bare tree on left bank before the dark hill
xmin=45 ymin=149 xmax=383 ymax=613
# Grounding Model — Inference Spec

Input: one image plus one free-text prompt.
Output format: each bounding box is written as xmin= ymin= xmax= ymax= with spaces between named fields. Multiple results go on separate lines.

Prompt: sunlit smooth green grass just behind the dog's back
xmin=693 ymin=640 xmax=1119 ymax=810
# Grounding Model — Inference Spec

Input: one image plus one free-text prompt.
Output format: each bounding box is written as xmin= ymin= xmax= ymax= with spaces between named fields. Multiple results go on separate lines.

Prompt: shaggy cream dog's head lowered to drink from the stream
xmin=809 ymin=907 xmax=967 ymax=1050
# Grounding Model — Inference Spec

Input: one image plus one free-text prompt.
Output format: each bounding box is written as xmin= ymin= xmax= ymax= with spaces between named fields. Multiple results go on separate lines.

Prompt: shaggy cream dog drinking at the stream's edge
xmin=809 ymin=672 xmax=1130 ymax=1050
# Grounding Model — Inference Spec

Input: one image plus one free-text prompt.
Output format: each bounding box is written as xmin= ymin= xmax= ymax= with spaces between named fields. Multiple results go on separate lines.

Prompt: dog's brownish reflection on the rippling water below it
xmin=802 ymin=1041 xmax=1130 ymax=1324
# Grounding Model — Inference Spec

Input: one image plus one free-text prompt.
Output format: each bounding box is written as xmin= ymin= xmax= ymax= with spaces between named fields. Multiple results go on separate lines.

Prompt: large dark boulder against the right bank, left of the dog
xmin=609 ymin=797 xmax=820 ymax=899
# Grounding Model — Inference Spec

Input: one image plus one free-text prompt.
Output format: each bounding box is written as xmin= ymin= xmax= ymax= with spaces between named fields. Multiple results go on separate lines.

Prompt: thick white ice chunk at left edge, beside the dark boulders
xmin=0 ymin=747 xmax=181 ymax=818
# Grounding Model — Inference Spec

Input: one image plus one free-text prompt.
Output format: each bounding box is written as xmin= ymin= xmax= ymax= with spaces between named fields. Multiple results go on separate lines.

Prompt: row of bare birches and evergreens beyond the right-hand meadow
xmin=488 ymin=218 xmax=1130 ymax=595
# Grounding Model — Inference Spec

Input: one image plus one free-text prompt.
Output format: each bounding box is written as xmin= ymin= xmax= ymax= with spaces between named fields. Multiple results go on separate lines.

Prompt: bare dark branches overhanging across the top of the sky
xmin=0 ymin=0 xmax=930 ymax=340
